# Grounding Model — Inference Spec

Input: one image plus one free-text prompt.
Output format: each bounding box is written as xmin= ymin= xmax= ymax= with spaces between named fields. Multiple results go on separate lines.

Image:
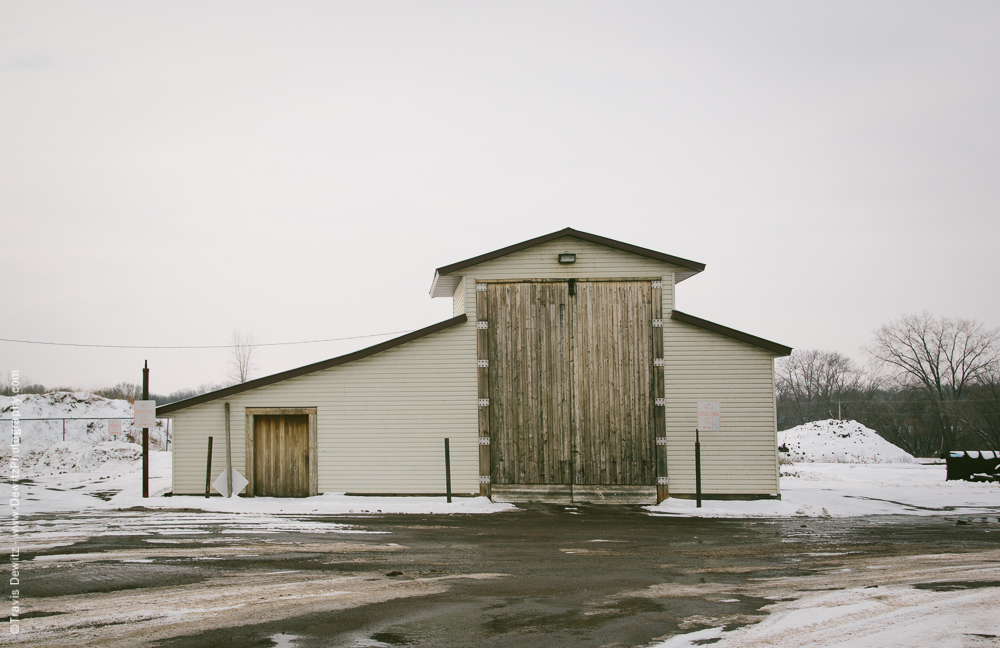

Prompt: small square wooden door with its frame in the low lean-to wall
xmin=253 ymin=414 xmax=309 ymax=497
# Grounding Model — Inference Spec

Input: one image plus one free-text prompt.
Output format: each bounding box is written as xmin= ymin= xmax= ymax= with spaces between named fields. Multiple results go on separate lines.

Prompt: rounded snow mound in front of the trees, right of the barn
xmin=778 ymin=419 xmax=914 ymax=463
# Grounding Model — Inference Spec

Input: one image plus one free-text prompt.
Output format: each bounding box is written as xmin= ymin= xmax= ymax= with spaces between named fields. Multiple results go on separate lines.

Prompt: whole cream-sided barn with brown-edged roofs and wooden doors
xmin=157 ymin=228 xmax=791 ymax=503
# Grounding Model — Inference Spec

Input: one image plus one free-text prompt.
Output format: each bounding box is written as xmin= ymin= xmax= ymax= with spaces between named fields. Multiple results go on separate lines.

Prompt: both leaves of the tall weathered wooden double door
xmin=487 ymin=281 xmax=656 ymax=485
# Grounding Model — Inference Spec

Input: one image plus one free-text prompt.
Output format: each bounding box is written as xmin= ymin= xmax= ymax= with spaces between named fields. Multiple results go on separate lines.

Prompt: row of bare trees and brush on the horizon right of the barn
xmin=775 ymin=313 xmax=1000 ymax=457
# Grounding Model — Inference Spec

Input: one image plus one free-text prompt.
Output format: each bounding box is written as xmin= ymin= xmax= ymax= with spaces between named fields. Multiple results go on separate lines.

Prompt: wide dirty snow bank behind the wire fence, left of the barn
xmin=0 ymin=392 xmax=158 ymax=477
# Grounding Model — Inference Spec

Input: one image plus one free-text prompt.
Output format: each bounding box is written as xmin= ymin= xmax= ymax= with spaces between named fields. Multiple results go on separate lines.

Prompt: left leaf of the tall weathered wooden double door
xmin=487 ymin=283 xmax=573 ymax=484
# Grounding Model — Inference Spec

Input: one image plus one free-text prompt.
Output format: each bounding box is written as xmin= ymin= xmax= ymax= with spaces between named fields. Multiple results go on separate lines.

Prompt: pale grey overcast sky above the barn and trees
xmin=0 ymin=0 xmax=1000 ymax=393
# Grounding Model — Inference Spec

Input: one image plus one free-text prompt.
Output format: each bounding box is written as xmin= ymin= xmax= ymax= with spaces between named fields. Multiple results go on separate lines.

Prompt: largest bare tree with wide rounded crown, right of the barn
xmin=866 ymin=313 xmax=1000 ymax=448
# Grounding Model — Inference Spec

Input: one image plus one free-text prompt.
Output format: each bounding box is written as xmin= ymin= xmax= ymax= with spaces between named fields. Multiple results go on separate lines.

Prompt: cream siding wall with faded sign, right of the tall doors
xmin=663 ymin=319 xmax=779 ymax=495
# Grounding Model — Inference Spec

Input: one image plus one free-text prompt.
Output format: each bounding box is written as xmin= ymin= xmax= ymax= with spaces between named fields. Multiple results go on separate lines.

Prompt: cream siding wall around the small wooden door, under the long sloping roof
xmin=173 ymin=321 xmax=479 ymax=494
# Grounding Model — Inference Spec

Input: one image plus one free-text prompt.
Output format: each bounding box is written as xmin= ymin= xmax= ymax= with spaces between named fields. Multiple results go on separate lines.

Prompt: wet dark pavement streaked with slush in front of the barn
xmin=13 ymin=505 xmax=1000 ymax=648
